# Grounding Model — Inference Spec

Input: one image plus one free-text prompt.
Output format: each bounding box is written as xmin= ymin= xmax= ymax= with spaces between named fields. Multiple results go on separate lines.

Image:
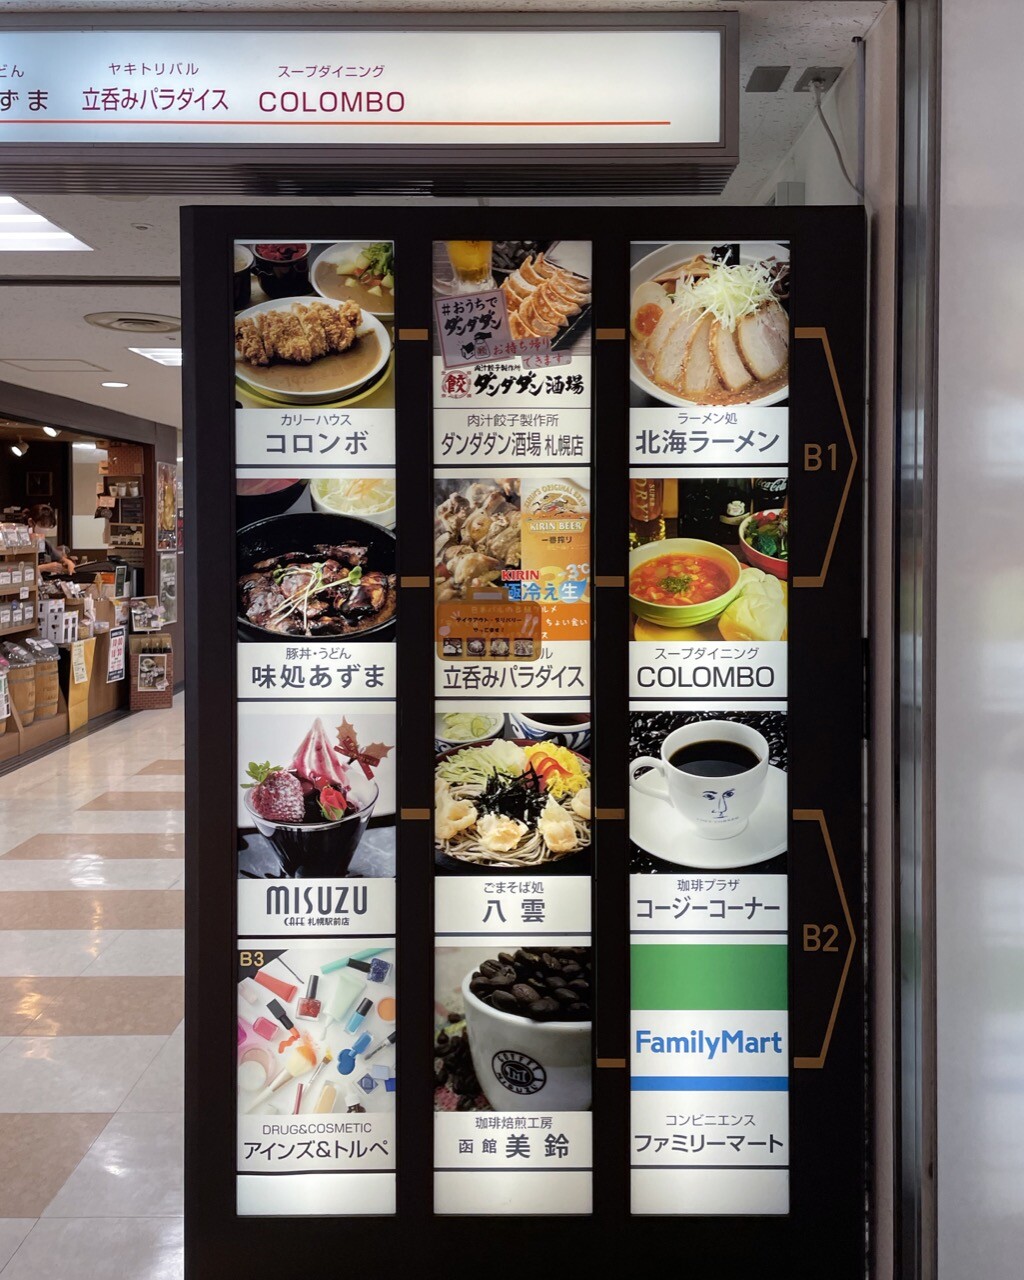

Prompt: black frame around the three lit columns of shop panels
xmin=182 ymin=206 xmax=870 ymax=1280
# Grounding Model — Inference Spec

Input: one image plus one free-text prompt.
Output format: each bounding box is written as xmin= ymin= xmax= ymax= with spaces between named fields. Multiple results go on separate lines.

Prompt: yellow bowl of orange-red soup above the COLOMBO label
xmin=630 ymin=538 xmax=741 ymax=627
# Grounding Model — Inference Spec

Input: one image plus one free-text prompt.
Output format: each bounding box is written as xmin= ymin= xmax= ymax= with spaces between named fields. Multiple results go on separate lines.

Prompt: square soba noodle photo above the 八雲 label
xmin=434 ymin=705 xmax=593 ymax=876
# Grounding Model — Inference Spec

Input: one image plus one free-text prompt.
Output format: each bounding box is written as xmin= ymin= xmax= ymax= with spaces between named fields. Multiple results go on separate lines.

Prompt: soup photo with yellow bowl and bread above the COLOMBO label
xmin=628 ymin=474 xmax=790 ymax=643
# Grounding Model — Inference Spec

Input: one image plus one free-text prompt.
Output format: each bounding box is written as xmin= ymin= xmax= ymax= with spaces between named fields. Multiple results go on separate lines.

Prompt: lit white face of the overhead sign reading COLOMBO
xmin=0 ymin=29 xmax=730 ymax=150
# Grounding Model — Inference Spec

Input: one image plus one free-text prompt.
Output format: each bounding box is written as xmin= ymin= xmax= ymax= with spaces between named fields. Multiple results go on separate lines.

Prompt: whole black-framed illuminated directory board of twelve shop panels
xmin=182 ymin=206 xmax=865 ymax=1276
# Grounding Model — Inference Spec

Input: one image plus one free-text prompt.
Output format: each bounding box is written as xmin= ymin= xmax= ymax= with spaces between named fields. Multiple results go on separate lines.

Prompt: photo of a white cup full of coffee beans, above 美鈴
xmin=434 ymin=938 xmax=594 ymax=1112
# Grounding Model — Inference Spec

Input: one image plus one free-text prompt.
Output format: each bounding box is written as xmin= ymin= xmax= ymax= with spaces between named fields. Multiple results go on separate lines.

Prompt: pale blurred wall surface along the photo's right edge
xmin=934 ymin=0 xmax=1024 ymax=1280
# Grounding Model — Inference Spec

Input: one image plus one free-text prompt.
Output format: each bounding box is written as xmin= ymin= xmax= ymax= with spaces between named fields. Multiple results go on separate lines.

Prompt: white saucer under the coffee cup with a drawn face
xmin=630 ymin=764 xmax=787 ymax=870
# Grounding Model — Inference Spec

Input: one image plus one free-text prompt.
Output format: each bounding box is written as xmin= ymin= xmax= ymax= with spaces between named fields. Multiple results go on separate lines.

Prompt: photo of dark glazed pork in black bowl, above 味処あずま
xmin=236 ymin=468 xmax=398 ymax=640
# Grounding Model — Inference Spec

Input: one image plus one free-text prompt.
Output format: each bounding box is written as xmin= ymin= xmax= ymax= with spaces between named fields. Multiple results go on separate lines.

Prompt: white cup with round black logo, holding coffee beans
xmin=462 ymin=970 xmax=593 ymax=1111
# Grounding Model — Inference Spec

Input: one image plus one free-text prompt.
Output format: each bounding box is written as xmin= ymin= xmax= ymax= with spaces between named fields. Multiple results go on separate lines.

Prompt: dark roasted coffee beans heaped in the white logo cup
xmin=470 ymin=947 xmax=593 ymax=1023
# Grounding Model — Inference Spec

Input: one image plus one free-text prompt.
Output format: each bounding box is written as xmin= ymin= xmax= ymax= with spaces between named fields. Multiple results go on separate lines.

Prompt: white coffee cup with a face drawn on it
xmin=630 ymin=721 xmax=768 ymax=840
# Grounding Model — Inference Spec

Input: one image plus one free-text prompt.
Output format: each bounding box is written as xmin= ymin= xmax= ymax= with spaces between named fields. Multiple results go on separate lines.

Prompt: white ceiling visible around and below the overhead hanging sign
xmin=0 ymin=0 xmax=886 ymax=426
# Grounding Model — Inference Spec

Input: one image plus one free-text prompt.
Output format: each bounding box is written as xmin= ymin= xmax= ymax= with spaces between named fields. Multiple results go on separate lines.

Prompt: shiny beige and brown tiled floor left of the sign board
xmin=0 ymin=698 xmax=184 ymax=1280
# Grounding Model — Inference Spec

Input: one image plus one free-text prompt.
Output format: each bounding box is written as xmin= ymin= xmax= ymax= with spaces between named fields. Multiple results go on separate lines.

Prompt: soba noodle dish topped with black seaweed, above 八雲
xmin=434 ymin=739 xmax=591 ymax=870
